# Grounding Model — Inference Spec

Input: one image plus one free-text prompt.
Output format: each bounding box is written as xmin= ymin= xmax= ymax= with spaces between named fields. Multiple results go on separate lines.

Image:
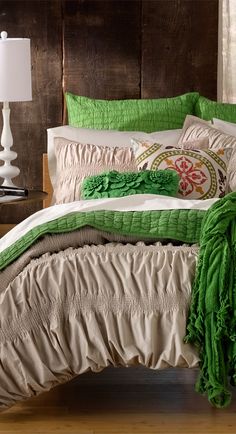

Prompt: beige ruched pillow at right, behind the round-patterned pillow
xmin=179 ymin=122 xmax=236 ymax=191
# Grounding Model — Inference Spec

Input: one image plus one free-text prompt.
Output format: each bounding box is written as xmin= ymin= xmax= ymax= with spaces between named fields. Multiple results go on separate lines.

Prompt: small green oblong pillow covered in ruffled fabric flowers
xmin=81 ymin=169 xmax=180 ymax=199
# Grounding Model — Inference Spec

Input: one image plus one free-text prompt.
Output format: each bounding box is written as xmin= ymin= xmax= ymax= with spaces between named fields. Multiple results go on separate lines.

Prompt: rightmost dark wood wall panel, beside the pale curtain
xmin=141 ymin=0 xmax=218 ymax=99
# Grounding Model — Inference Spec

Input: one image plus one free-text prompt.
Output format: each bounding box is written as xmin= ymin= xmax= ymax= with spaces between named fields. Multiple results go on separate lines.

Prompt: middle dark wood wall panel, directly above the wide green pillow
xmin=64 ymin=0 xmax=141 ymax=105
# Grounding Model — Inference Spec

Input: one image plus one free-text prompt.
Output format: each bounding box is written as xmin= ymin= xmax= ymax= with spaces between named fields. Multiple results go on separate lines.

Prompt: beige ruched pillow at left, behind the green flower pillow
xmin=52 ymin=137 xmax=137 ymax=204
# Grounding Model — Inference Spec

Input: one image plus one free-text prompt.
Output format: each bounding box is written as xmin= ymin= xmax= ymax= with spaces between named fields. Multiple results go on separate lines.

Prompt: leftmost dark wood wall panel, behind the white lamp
xmin=0 ymin=0 xmax=62 ymax=223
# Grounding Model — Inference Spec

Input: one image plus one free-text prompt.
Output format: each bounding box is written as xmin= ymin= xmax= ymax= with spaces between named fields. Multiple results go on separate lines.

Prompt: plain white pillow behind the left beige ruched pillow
xmin=47 ymin=125 xmax=182 ymax=188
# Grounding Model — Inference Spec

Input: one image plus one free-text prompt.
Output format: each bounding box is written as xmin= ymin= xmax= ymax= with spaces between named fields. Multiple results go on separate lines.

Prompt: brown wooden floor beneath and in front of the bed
xmin=0 ymin=368 xmax=236 ymax=434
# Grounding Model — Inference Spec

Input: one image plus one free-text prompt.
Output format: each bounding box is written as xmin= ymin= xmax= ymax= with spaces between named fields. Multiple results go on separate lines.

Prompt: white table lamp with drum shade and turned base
xmin=0 ymin=32 xmax=32 ymax=187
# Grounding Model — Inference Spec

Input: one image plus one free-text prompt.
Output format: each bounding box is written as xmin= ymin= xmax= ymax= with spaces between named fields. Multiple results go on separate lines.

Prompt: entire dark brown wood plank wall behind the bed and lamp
xmin=0 ymin=0 xmax=218 ymax=223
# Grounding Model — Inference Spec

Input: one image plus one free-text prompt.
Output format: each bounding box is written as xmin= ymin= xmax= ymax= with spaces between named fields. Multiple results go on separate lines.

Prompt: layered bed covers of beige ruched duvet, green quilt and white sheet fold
xmin=0 ymin=196 xmax=227 ymax=409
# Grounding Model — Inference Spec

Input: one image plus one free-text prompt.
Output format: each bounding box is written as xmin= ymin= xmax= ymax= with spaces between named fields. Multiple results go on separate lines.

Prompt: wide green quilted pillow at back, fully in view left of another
xmin=66 ymin=92 xmax=199 ymax=133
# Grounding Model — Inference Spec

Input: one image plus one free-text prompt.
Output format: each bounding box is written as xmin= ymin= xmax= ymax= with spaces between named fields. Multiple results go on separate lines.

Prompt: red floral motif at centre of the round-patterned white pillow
xmin=165 ymin=156 xmax=207 ymax=196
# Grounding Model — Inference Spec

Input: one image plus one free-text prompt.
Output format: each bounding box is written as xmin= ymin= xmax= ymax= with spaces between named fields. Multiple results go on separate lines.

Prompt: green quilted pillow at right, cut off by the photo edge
xmin=195 ymin=96 xmax=236 ymax=122
